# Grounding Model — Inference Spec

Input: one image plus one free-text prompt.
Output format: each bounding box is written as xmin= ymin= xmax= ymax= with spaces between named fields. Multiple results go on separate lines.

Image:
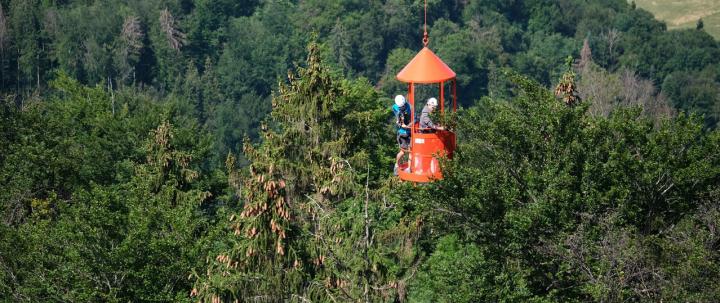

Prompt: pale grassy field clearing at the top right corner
xmin=635 ymin=0 xmax=720 ymax=40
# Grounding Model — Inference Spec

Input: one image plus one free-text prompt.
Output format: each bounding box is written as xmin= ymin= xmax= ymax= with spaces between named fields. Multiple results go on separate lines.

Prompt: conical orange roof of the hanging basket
xmin=396 ymin=47 xmax=455 ymax=83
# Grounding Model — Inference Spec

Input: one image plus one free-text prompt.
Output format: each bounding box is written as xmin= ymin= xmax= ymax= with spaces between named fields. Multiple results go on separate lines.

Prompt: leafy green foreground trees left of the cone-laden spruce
xmin=0 ymin=75 xmax=217 ymax=302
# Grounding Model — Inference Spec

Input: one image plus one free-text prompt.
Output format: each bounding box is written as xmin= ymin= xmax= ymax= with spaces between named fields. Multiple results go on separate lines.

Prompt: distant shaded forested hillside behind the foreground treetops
xmin=0 ymin=0 xmax=718 ymax=142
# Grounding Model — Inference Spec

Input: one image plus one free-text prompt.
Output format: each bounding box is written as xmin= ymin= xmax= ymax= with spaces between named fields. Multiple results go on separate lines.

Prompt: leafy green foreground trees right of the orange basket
xmin=416 ymin=72 xmax=720 ymax=301
